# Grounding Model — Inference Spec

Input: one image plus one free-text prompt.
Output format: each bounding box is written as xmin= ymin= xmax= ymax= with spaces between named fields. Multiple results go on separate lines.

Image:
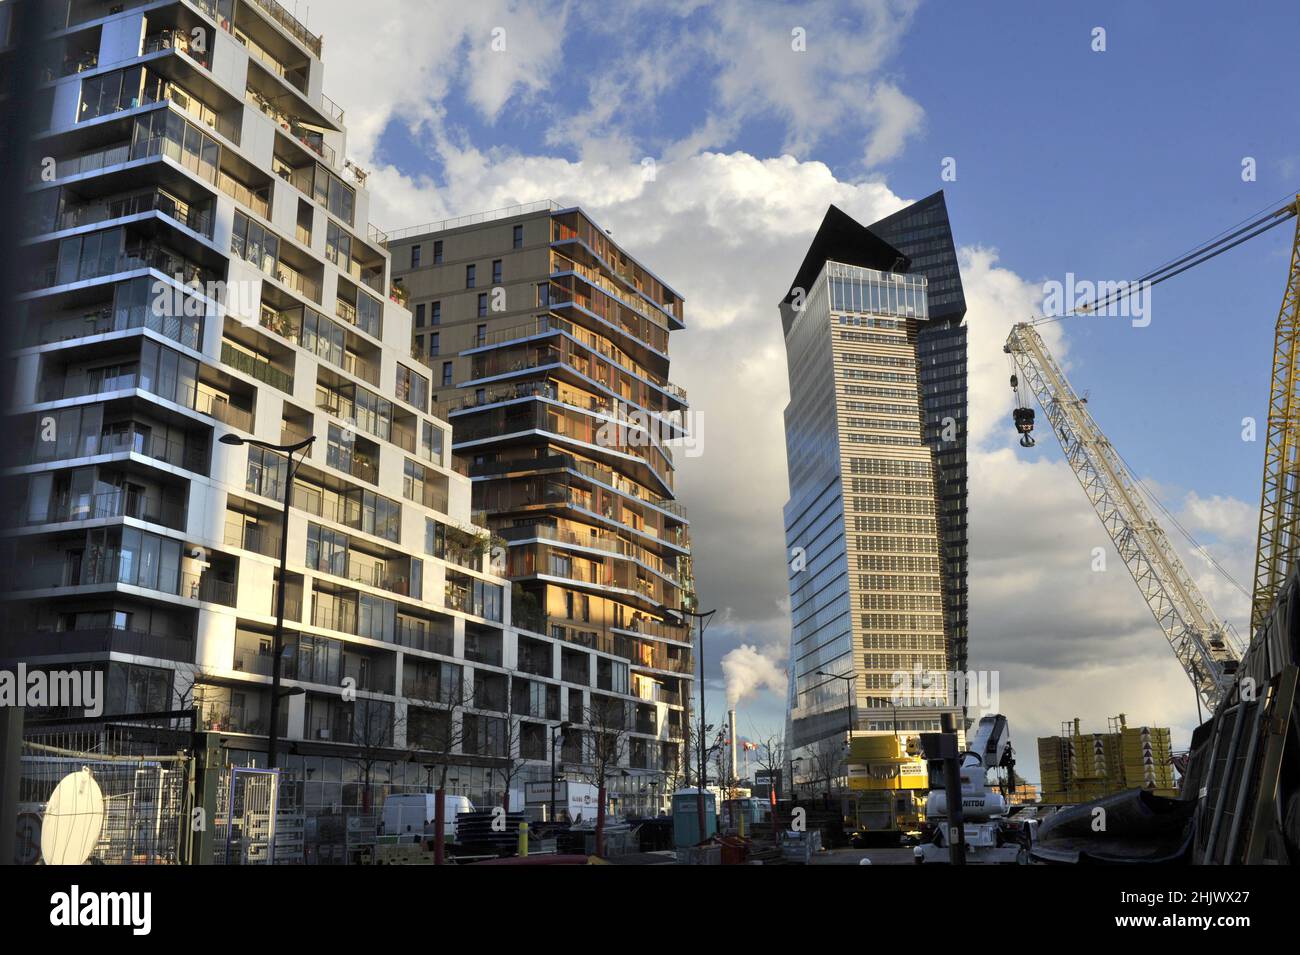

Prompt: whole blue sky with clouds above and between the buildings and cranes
xmin=299 ymin=0 xmax=1300 ymax=780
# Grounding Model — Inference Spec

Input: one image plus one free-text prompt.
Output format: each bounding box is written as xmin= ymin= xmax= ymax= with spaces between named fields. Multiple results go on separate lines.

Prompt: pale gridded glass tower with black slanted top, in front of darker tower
xmin=780 ymin=207 xmax=953 ymax=780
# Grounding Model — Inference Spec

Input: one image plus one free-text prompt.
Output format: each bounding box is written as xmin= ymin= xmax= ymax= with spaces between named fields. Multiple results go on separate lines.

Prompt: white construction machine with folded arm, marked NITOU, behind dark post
xmin=911 ymin=713 xmax=1032 ymax=864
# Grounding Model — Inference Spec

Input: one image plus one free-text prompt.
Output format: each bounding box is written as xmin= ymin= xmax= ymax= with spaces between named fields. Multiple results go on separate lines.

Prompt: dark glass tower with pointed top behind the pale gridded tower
xmin=867 ymin=191 xmax=967 ymax=673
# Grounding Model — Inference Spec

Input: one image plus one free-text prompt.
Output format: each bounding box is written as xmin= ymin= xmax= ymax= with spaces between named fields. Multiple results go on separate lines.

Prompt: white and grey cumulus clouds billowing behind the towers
xmin=312 ymin=0 xmax=1253 ymax=777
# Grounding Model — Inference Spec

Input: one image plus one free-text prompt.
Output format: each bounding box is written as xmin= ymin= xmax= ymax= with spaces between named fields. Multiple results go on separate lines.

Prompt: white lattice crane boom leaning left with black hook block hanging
xmin=1004 ymin=324 xmax=1239 ymax=709
